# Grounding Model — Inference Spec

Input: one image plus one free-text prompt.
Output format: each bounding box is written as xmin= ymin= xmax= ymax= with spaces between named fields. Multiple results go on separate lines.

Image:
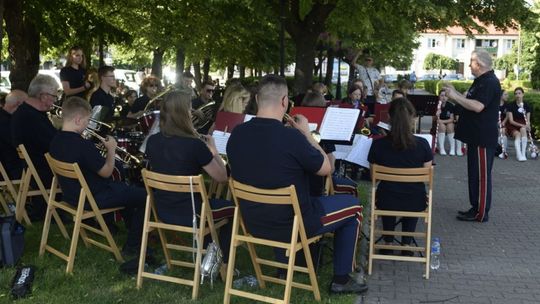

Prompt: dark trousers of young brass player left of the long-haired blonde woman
xmin=94 ymin=182 xmax=146 ymax=248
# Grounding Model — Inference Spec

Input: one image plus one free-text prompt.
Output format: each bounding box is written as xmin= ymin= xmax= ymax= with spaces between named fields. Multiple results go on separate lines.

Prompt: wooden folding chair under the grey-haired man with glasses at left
xmin=15 ymin=144 xmax=61 ymax=225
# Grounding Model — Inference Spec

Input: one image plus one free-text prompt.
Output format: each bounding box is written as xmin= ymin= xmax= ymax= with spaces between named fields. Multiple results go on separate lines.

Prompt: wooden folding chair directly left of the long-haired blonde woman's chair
xmin=39 ymin=153 xmax=124 ymax=273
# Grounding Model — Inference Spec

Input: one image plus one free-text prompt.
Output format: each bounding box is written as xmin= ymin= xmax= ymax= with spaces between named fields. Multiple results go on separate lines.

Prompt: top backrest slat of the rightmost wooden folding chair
xmin=371 ymin=164 xmax=433 ymax=185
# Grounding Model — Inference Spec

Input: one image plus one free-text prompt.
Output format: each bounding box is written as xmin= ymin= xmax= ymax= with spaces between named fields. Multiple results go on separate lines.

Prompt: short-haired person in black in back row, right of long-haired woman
xmin=90 ymin=65 xmax=116 ymax=121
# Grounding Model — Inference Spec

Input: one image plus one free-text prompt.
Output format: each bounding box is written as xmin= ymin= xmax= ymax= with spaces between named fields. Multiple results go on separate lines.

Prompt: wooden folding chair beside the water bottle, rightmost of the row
xmin=368 ymin=165 xmax=433 ymax=279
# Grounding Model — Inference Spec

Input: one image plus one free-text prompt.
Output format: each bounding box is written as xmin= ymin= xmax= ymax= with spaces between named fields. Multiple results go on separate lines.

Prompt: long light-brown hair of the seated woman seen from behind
xmin=159 ymin=88 xmax=197 ymax=138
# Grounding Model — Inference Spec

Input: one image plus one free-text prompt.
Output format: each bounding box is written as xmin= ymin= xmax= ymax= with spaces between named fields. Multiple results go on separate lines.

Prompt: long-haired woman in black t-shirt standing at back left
xmin=60 ymin=46 xmax=92 ymax=98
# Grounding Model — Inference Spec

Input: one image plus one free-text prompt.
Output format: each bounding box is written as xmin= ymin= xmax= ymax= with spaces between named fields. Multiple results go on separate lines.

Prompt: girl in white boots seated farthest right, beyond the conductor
xmin=506 ymin=87 xmax=531 ymax=161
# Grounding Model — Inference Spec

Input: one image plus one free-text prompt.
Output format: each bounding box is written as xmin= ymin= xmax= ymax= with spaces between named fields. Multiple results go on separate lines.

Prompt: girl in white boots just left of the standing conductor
xmin=437 ymin=90 xmax=456 ymax=155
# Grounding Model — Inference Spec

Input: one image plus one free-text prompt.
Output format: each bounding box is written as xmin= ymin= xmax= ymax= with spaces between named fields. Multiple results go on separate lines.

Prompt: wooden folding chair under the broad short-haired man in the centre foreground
xmin=223 ymin=179 xmax=321 ymax=304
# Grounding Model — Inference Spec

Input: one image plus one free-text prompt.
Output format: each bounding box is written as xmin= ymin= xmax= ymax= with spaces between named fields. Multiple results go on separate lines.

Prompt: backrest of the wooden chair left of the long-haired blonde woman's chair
xmin=45 ymin=153 xmax=99 ymax=211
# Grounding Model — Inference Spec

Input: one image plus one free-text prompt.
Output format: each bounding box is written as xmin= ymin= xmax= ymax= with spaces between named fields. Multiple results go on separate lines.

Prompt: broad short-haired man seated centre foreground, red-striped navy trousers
xmin=227 ymin=75 xmax=367 ymax=293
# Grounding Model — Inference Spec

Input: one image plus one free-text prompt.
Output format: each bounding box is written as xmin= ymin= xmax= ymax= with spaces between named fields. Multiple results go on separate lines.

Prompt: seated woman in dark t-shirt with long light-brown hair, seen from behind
xmin=146 ymin=88 xmax=234 ymax=262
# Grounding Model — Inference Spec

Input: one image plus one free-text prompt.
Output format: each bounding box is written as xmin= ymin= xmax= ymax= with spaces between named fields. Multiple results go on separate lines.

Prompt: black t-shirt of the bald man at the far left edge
xmin=0 ymin=108 xmax=24 ymax=180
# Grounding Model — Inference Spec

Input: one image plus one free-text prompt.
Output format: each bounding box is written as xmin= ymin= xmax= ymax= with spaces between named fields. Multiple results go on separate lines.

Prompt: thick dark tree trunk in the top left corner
xmin=4 ymin=0 xmax=40 ymax=91
